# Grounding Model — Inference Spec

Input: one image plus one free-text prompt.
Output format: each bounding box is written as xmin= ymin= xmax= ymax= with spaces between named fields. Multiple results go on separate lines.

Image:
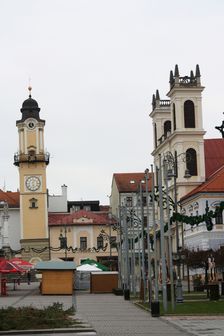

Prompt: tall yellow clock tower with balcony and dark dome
xmin=14 ymin=87 xmax=49 ymax=260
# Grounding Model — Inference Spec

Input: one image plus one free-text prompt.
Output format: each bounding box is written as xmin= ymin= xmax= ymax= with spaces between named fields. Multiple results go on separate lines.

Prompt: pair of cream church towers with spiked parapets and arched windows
xmin=150 ymin=65 xmax=205 ymax=199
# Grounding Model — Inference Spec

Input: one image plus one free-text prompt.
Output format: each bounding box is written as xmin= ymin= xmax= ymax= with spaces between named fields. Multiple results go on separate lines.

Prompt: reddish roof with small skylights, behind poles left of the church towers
xmin=113 ymin=173 xmax=152 ymax=192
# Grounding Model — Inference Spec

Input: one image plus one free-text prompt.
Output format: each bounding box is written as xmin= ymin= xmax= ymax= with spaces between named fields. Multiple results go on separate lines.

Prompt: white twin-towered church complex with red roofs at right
xmin=150 ymin=65 xmax=224 ymax=249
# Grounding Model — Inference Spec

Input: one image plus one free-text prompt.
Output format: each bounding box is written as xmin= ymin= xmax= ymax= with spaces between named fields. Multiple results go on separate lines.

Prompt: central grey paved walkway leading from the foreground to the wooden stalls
xmin=77 ymin=292 xmax=189 ymax=336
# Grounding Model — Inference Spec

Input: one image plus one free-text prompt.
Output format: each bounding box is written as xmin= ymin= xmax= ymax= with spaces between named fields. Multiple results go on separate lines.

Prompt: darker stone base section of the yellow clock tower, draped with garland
xmin=20 ymin=238 xmax=50 ymax=263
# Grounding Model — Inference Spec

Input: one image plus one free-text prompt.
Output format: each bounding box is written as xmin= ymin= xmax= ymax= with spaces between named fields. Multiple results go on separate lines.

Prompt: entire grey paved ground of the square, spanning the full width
xmin=0 ymin=283 xmax=224 ymax=336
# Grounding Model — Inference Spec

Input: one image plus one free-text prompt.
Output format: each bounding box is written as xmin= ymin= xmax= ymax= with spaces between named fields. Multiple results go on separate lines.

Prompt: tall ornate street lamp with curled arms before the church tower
xmin=164 ymin=151 xmax=191 ymax=303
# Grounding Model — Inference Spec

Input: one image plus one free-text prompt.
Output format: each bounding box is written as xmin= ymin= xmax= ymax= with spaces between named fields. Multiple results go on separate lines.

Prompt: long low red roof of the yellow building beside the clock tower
xmin=48 ymin=210 xmax=115 ymax=226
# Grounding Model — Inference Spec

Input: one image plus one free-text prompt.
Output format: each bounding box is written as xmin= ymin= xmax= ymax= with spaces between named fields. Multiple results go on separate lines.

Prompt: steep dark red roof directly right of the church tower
xmin=204 ymin=139 xmax=224 ymax=179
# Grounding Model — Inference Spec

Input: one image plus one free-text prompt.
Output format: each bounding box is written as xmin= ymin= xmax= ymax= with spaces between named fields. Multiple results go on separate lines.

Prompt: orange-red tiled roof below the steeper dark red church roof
xmin=181 ymin=166 xmax=224 ymax=201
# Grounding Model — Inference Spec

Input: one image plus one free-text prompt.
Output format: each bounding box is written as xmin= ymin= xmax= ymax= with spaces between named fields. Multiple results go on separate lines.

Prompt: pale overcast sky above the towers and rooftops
xmin=0 ymin=0 xmax=224 ymax=204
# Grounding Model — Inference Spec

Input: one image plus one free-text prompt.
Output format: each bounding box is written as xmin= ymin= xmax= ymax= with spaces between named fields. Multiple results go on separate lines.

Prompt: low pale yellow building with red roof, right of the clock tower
xmin=49 ymin=210 xmax=117 ymax=270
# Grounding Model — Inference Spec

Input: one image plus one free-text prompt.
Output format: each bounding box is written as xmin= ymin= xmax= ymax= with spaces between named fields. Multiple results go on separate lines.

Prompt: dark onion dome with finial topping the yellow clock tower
xmin=18 ymin=86 xmax=44 ymax=122
